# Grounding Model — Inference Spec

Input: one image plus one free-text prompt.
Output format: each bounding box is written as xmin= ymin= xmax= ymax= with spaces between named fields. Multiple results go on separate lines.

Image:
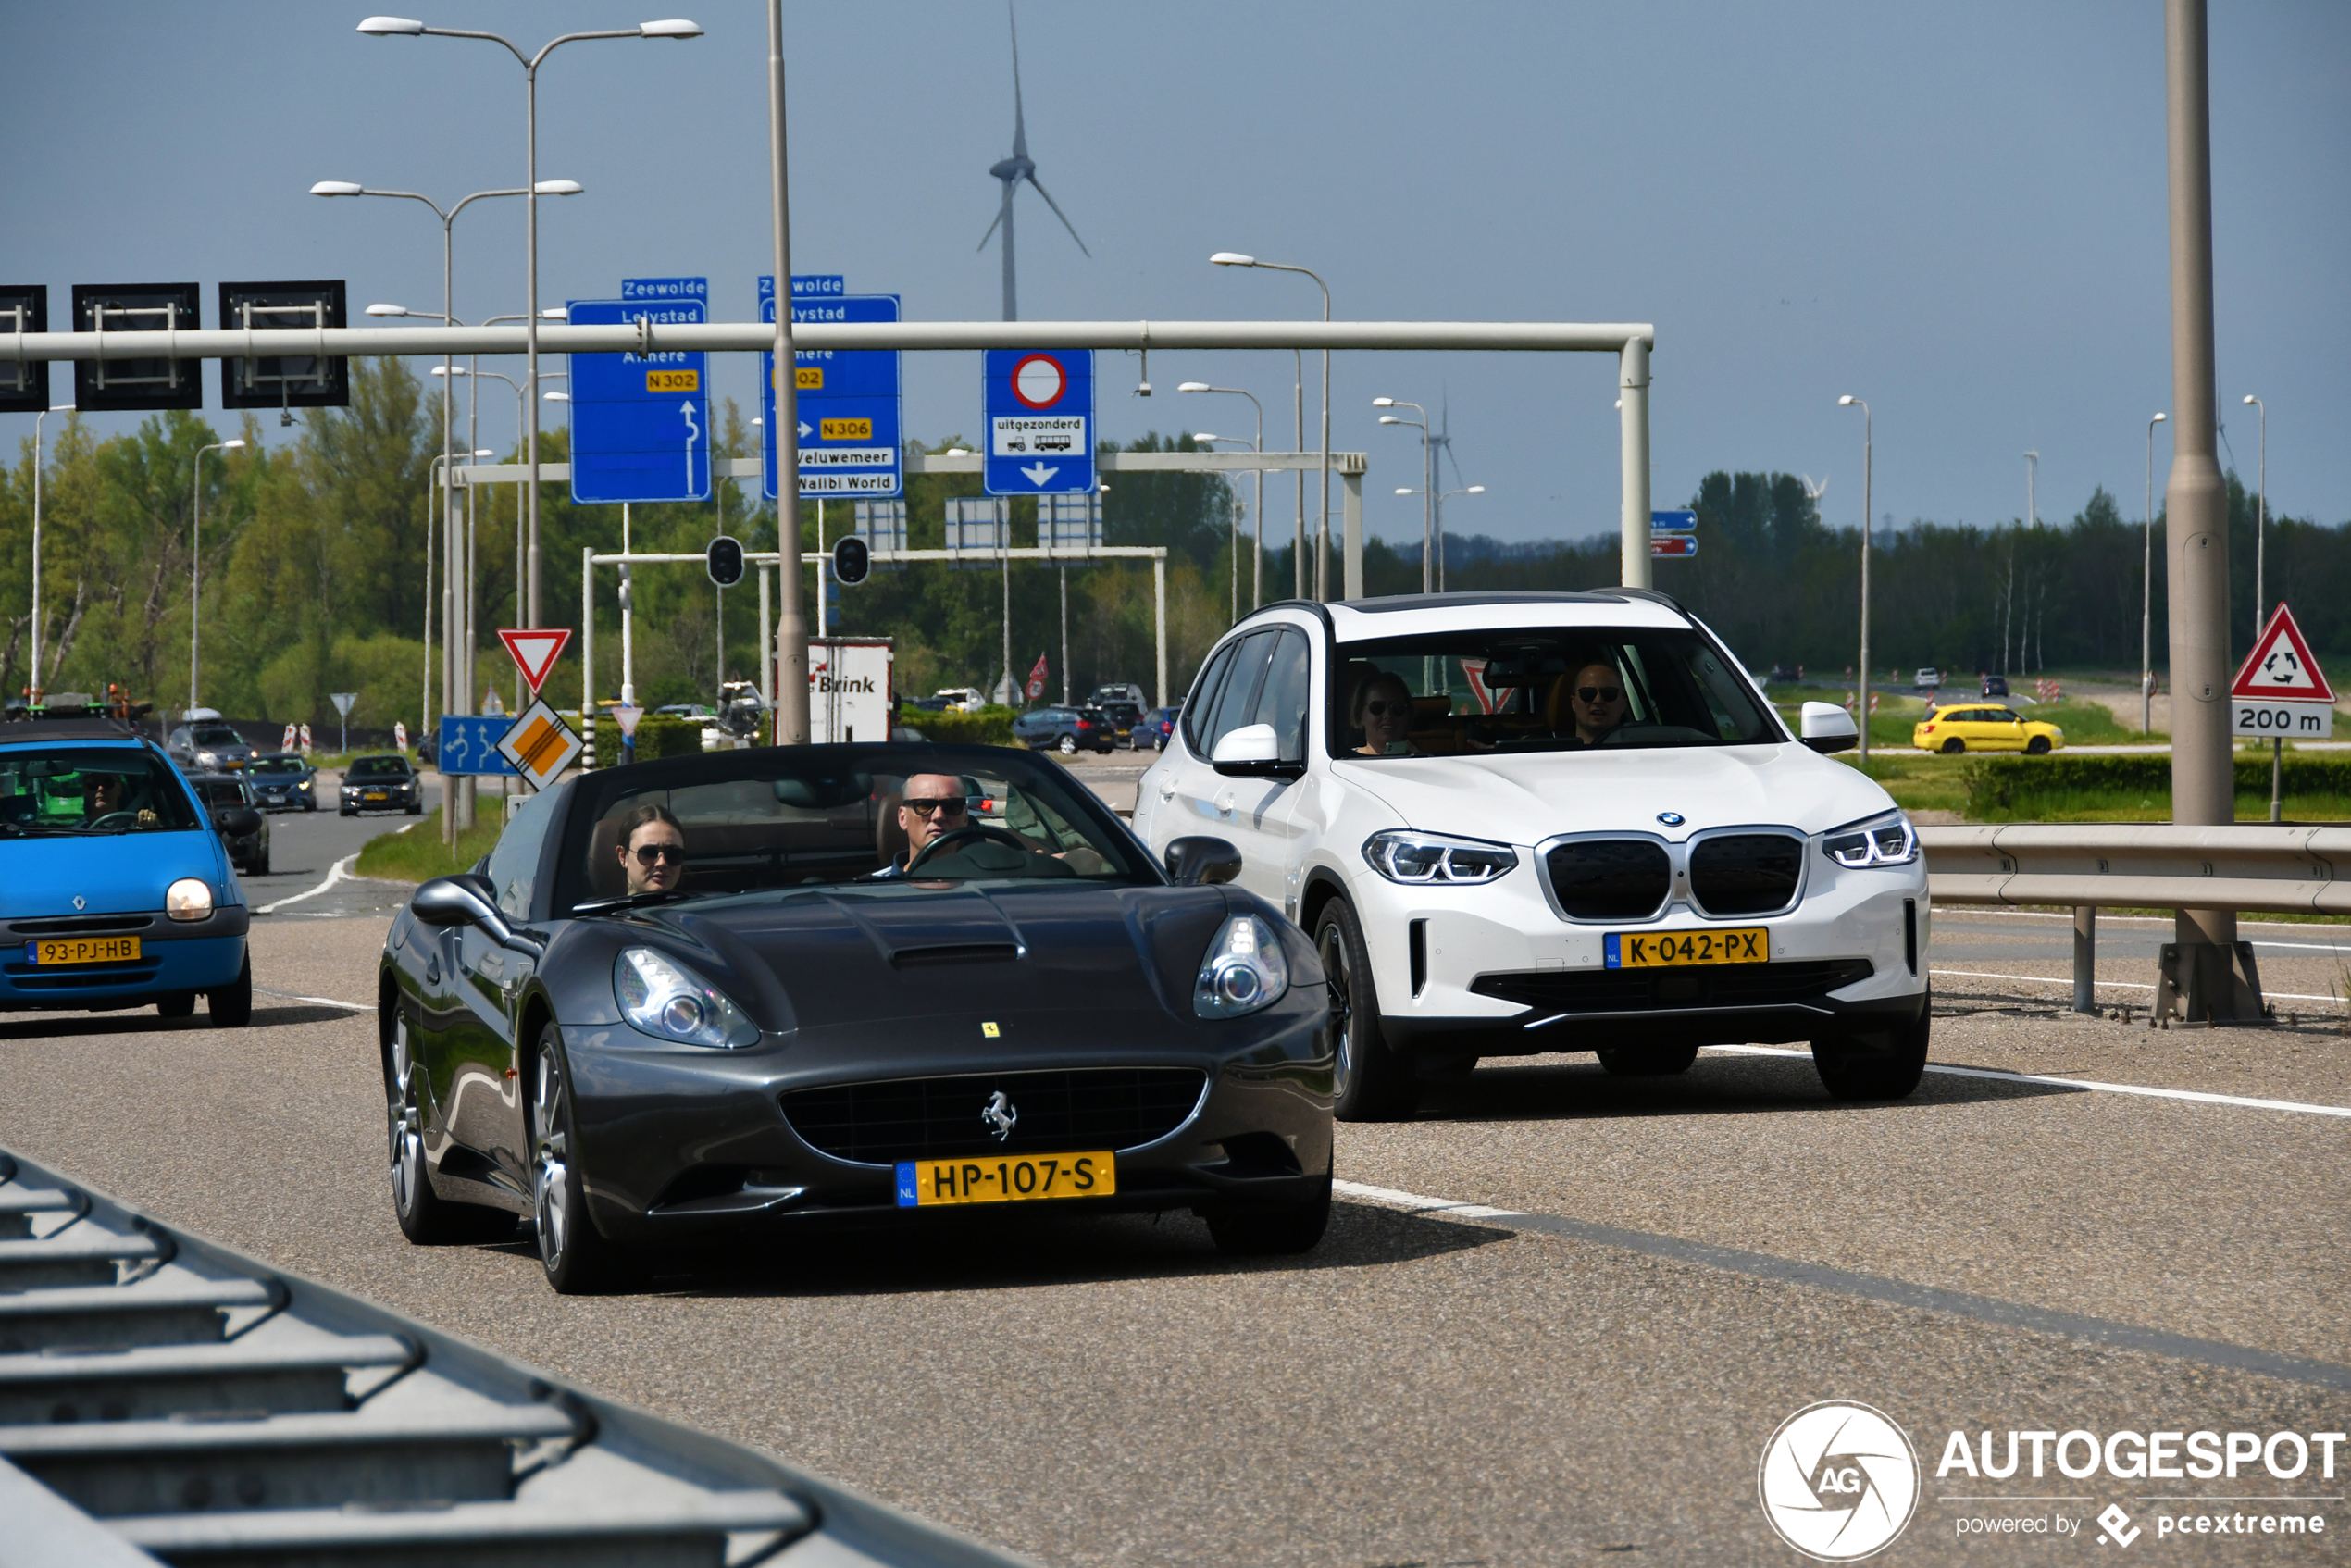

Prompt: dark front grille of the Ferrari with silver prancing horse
xmin=783 ymin=1067 xmax=1209 ymax=1166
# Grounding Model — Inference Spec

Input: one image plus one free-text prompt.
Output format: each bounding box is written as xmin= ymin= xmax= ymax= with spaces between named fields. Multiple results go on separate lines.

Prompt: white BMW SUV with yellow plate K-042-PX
xmin=1136 ymin=588 xmax=1928 ymax=1121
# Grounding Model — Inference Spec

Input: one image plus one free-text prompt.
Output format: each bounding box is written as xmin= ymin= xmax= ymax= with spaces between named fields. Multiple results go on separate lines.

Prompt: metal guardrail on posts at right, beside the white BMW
xmin=1919 ymin=823 xmax=2351 ymax=1018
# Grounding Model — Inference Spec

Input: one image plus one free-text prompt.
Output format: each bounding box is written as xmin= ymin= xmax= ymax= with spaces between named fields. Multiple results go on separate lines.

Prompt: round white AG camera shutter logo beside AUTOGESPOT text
xmin=1756 ymin=1399 xmax=1919 ymax=1563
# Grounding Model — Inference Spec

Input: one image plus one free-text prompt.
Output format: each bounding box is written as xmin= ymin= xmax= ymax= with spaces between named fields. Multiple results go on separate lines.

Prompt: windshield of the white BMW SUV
xmin=1328 ymin=626 xmax=1785 ymax=757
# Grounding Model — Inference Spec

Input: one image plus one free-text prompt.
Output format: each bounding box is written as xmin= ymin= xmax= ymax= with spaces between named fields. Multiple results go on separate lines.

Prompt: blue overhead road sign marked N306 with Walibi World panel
xmin=759 ymin=273 xmax=905 ymax=501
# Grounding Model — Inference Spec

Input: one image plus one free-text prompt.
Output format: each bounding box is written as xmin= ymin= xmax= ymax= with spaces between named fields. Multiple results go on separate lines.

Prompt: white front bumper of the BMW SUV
xmin=1347 ymin=840 xmax=1930 ymax=1055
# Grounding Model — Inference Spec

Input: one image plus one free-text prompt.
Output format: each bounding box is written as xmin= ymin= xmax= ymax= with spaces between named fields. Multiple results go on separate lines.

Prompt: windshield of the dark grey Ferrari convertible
xmin=554 ymin=745 xmax=1159 ymax=910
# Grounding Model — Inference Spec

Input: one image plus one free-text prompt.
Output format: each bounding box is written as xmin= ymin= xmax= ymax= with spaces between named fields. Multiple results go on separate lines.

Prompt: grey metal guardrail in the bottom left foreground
xmin=0 ymin=1150 xmax=1020 ymax=1568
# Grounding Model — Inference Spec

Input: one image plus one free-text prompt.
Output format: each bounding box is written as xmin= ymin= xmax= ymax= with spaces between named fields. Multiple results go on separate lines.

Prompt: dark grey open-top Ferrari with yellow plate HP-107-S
xmin=379 ymin=745 xmax=1333 ymax=1290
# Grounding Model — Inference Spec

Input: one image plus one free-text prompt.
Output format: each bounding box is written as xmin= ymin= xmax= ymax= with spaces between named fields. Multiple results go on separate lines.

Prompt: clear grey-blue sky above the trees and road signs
xmin=0 ymin=0 xmax=2351 ymax=550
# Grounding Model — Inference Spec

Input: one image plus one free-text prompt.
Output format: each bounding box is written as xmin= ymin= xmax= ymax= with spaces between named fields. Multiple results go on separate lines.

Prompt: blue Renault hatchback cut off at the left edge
xmin=0 ymin=717 xmax=256 ymax=1027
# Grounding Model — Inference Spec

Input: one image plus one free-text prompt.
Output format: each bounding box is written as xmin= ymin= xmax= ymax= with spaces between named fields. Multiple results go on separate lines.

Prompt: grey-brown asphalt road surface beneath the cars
xmin=0 ymin=902 xmax=2351 ymax=1568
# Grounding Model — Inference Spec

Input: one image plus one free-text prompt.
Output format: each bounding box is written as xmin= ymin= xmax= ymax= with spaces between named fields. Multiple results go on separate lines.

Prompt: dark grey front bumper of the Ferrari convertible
xmin=541 ymin=988 xmax=1333 ymax=1244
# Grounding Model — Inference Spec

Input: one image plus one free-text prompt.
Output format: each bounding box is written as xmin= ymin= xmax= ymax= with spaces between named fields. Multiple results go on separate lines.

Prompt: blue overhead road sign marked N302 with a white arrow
xmin=571 ymin=278 xmax=710 ymax=505
